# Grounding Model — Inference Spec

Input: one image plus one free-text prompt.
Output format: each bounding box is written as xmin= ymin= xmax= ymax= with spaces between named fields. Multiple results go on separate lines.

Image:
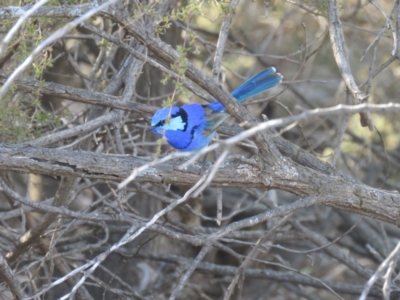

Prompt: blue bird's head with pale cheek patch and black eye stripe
xmin=149 ymin=106 xmax=188 ymax=137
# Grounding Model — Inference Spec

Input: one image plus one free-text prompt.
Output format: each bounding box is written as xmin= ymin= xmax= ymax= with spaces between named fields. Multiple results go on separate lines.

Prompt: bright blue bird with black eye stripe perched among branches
xmin=149 ymin=67 xmax=283 ymax=151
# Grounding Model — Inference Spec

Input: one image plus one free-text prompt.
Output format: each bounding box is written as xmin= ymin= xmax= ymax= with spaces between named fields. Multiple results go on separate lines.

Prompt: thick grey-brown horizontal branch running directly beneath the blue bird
xmin=0 ymin=145 xmax=400 ymax=225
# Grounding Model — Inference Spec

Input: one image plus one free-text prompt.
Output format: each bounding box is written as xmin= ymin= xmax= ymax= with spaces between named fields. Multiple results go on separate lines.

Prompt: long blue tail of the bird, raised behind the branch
xmin=206 ymin=67 xmax=283 ymax=112
